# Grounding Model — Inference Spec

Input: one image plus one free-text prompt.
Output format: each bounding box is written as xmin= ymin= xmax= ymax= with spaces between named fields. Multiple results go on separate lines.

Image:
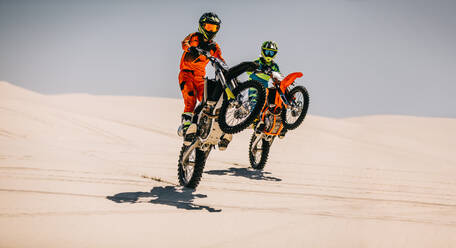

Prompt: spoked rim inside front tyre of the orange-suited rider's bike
xmin=225 ymin=87 xmax=258 ymax=127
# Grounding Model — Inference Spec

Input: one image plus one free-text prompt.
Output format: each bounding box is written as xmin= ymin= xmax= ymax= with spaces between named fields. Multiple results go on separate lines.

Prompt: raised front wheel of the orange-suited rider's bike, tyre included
xmin=218 ymin=80 xmax=266 ymax=134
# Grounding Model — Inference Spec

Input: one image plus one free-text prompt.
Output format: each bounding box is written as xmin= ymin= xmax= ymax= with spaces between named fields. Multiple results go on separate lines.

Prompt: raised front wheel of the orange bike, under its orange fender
xmin=281 ymin=86 xmax=309 ymax=130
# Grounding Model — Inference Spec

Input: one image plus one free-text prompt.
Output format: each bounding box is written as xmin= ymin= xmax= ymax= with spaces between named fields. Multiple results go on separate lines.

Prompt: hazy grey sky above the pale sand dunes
xmin=0 ymin=0 xmax=456 ymax=117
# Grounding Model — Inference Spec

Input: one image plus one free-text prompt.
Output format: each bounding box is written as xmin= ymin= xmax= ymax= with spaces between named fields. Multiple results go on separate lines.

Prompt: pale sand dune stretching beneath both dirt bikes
xmin=0 ymin=82 xmax=456 ymax=247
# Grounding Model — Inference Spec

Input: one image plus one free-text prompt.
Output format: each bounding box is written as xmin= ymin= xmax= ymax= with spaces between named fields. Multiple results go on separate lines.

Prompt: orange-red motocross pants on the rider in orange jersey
xmin=179 ymin=70 xmax=204 ymax=112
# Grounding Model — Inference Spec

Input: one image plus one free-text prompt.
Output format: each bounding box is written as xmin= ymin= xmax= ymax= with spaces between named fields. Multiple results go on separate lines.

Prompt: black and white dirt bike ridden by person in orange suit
xmin=178 ymin=48 xmax=266 ymax=188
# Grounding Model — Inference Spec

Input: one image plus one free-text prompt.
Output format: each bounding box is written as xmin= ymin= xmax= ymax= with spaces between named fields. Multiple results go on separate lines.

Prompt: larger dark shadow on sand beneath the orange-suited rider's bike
xmin=106 ymin=186 xmax=222 ymax=212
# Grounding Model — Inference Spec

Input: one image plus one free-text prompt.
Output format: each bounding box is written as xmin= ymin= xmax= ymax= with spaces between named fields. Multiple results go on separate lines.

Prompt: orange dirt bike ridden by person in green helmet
xmin=249 ymin=72 xmax=309 ymax=170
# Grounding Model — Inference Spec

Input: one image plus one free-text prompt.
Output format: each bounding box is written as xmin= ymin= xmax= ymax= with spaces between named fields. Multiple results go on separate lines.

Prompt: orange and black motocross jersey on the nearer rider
xmin=180 ymin=32 xmax=225 ymax=77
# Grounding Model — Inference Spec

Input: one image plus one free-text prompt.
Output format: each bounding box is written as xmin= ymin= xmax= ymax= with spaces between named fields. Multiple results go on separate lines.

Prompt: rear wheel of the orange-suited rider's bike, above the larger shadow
xmin=177 ymin=146 xmax=206 ymax=189
